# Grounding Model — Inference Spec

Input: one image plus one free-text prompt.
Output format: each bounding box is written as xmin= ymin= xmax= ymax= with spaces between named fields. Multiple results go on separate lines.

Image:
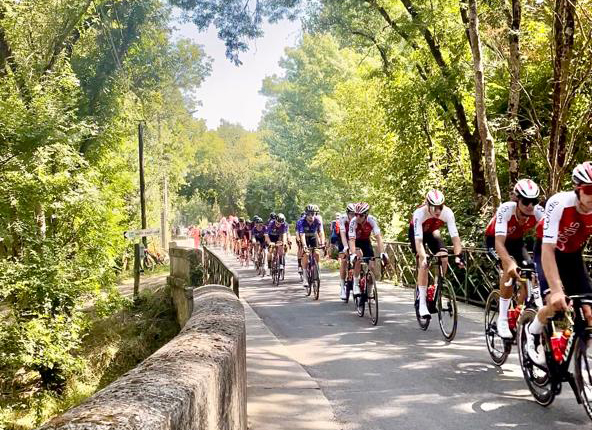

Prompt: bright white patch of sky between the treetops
xmin=175 ymin=20 xmax=302 ymax=130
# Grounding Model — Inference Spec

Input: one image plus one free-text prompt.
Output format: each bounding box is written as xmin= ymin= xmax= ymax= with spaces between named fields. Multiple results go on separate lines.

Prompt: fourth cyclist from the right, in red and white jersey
xmin=348 ymin=202 xmax=388 ymax=297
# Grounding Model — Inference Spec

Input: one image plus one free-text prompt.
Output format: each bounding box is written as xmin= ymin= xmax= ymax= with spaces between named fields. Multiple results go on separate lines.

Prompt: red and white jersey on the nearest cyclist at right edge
xmin=537 ymin=191 xmax=592 ymax=253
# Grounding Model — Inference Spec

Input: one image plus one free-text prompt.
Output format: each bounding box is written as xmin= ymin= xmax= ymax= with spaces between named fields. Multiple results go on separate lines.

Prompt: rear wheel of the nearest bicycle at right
xmin=517 ymin=309 xmax=555 ymax=406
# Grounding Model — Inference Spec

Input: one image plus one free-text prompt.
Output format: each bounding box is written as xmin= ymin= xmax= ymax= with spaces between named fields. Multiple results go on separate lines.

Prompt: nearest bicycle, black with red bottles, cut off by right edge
xmin=518 ymin=293 xmax=592 ymax=419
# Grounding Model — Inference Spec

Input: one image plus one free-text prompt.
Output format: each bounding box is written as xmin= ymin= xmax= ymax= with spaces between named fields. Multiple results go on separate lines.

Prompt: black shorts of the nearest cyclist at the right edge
xmin=534 ymin=240 xmax=592 ymax=296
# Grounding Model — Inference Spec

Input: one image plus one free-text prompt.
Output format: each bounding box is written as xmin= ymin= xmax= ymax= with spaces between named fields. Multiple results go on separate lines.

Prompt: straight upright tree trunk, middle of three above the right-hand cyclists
xmin=507 ymin=0 xmax=522 ymax=188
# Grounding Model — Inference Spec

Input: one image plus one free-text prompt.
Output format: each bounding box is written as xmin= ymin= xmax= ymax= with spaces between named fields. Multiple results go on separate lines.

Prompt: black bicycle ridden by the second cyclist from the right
xmin=485 ymin=263 xmax=543 ymax=366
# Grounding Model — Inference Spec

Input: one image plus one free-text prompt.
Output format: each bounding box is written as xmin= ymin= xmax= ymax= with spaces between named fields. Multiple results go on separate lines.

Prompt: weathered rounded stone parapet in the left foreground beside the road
xmin=42 ymin=285 xmax=247 ymax=430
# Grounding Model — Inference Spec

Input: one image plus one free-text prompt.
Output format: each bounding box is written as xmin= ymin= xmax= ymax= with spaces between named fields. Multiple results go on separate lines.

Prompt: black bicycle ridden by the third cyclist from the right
xmin=415 ymin=253 xmax=458 ymax=342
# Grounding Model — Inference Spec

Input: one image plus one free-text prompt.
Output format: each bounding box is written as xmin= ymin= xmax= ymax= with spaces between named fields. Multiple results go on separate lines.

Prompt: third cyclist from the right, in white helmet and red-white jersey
xmin=409 ymin=190 xmax=463 ymax=318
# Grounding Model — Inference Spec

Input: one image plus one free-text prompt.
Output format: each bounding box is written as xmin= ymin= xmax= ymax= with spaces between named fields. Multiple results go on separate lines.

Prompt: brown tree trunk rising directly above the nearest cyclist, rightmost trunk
xmin=547 ymin=0 xmax=576 ymax=195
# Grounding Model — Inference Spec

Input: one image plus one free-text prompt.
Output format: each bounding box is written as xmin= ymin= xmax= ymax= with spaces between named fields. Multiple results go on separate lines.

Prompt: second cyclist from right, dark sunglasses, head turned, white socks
xmin=485 ymin=179 xmax=543 ymax=339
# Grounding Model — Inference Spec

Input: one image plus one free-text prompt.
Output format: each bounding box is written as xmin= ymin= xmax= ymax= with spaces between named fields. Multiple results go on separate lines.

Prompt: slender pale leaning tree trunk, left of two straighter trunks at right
xmin=468 ymin=0 xmax=501 ymax=207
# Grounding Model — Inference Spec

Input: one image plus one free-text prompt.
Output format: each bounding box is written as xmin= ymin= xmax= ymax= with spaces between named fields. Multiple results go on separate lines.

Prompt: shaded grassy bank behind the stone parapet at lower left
xmin=0 ymin=286 xmax=179 ymax=430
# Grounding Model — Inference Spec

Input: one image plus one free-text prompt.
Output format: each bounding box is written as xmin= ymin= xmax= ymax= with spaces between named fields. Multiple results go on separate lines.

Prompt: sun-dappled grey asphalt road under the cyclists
xmin=219 ymin=250 xmax=592 ymax=430
